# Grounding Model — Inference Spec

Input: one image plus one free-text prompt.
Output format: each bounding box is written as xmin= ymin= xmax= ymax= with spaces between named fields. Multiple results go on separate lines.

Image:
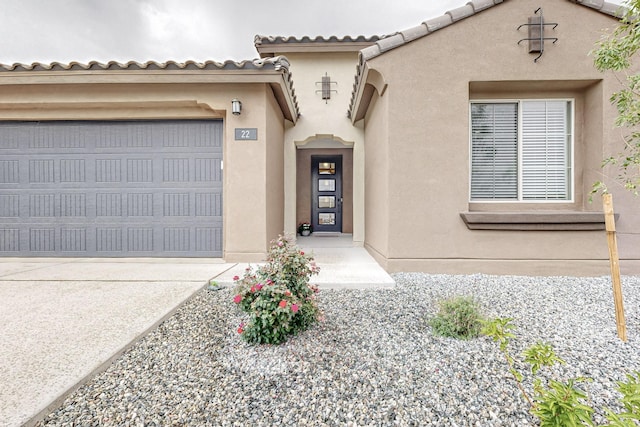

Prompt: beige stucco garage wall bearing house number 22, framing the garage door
xmin=0 ymin=78 xmax=285 ymax=262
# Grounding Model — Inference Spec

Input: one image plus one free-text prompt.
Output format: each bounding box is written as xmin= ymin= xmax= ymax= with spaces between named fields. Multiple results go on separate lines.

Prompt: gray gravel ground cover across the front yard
xmin=37 ymin=273 xmax=640 ymax=427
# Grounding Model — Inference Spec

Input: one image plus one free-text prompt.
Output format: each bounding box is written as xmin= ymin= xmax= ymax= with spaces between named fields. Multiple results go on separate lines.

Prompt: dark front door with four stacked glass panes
xmin=311 ymin=156 xmax=342 ymax=233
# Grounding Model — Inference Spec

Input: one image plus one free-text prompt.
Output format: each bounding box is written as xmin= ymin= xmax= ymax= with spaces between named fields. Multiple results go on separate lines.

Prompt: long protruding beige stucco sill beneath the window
xmin=460 ymin=211 xmax=605 ymax=231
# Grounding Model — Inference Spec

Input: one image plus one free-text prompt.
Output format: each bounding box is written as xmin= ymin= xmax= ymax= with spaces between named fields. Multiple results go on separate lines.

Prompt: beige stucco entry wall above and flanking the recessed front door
xmin=285 ymin=52 xmax=364 ymax=245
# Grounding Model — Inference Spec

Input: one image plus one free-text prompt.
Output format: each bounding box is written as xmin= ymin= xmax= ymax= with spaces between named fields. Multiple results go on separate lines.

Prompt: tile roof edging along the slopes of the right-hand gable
xmin=347 ymin=0 xmax=625 ymax=118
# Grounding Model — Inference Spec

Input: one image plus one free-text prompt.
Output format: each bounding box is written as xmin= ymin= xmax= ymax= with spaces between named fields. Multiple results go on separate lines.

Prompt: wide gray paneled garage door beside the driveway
xmin=0 ymin=120 xmax=222 ymax=257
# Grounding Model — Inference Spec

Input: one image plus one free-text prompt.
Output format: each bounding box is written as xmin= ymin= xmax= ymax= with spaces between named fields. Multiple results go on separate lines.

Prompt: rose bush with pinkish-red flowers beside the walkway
xmin=233 ymin=236 xmax=320 ymax=344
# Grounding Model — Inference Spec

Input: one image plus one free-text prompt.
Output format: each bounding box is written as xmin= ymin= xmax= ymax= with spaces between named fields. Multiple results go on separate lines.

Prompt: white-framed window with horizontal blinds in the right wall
xmin=471 ymin=100 xmax=573 ymax=201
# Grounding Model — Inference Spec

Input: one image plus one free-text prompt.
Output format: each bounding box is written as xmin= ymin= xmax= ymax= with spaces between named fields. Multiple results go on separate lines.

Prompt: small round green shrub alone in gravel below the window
xmin=429 ymin=296 xmax=482 ymax=340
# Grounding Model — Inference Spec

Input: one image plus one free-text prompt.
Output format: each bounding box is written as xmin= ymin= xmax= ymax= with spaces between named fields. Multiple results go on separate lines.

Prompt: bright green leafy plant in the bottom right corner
xmin=482 ymin=318 xmax=640 ymax=427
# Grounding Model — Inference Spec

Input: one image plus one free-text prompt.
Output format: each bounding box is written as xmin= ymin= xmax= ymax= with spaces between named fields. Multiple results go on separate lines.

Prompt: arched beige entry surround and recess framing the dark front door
xmin=285 ymin=135 xmax=364 ymax=246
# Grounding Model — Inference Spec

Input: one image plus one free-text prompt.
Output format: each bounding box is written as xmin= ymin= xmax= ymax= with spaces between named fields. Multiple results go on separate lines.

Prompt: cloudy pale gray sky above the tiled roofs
xmin=0 ymin=0 xmax=622 ymax=65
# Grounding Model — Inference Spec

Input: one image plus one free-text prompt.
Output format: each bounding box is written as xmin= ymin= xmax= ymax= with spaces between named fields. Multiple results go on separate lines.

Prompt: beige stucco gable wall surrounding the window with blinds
xmin=365 ymin=0 xmax=640 ymax=274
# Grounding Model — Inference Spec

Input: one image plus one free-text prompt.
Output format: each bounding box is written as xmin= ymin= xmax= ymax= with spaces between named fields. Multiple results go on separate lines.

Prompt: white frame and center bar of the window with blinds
xmin=467 ymin=97 xmax=576 ymax=204
